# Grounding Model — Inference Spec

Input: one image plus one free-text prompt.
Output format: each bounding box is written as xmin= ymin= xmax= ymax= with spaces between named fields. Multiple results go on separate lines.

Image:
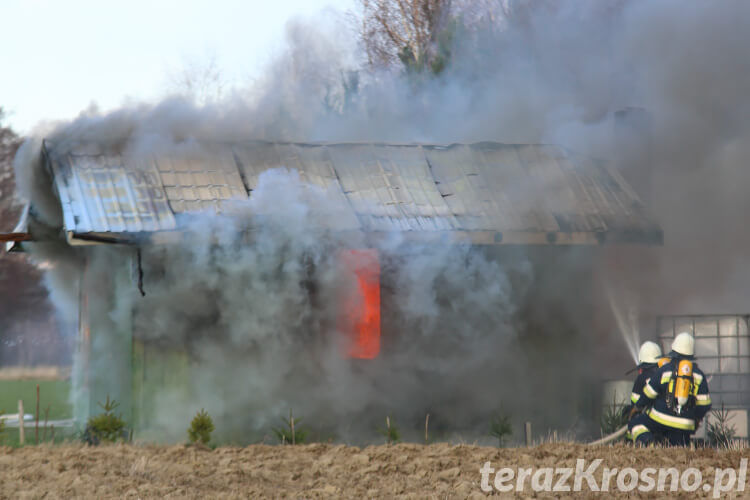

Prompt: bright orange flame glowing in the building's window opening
xmin=339 ymin=249 xmax=380 ymax=359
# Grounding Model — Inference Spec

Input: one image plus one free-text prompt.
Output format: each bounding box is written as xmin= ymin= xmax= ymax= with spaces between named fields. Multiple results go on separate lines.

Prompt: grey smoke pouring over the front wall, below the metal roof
xmin=123 ymin=170 xmax=528 ymax=437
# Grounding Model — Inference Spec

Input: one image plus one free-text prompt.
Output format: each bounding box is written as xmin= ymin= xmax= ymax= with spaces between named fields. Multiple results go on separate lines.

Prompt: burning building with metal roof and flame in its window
xmin=5 ymin=136 xmax=662 ymax=439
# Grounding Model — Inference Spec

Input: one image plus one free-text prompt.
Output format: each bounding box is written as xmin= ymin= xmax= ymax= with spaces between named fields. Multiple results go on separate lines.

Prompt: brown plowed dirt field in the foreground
xmin=0 ymin=443 xmax=750 ymax=499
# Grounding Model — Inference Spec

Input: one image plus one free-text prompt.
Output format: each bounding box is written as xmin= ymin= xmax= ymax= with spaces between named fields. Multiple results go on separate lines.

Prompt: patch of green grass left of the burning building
xmin=0 ymin=380 xmax=73 ymax=426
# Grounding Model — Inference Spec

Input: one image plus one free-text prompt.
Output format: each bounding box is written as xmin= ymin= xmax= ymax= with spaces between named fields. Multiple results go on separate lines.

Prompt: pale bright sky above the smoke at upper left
xmin=0 ymin=0 xmax=354 ymax=134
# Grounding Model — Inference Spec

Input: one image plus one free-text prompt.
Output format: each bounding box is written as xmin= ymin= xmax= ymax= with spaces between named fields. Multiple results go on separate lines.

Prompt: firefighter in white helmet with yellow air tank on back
xmin=631 ymin=333 xmax=711 ymax=446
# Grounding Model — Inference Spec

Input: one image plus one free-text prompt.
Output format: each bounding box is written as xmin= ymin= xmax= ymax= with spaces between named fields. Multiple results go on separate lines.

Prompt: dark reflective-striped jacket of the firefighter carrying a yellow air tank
xmin=636 ymin=357 xmax=711 ymax=432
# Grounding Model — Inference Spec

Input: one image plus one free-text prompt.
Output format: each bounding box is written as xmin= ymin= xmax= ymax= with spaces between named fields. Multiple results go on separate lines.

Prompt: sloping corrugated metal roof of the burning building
xmin=42 ymin=142 xmax=662 ymax=244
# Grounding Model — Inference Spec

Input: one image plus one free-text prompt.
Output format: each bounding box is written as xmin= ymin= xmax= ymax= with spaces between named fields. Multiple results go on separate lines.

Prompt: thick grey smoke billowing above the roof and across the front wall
xmin=17 ymin=0 xmax=750 ymax=442
